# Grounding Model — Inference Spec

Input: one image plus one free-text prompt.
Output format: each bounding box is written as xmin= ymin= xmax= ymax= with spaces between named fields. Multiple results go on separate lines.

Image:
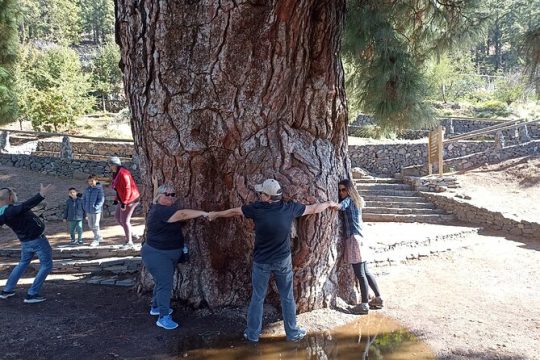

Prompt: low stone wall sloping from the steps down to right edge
xmin=420 ymin=192 xmax=540 ymax=240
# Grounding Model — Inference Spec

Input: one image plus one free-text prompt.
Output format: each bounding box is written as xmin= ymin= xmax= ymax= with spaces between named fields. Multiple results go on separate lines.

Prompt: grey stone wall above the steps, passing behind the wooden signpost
xmin=349 ymin=141 xmax=495 ymax=175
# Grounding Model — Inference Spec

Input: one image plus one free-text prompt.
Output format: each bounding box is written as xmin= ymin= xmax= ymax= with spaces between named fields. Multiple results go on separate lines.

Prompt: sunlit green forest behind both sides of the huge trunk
xmin=0 ymin=0 xmax=540 ymax=138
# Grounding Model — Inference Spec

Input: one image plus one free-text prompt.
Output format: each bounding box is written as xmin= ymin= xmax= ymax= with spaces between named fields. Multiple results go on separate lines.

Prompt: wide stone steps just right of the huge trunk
xmin=354 ymin=177 xmax=455 ymax=224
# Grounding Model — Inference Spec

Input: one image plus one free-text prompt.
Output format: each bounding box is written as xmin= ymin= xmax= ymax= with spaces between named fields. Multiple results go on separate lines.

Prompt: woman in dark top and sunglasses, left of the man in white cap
xmin=141 ymin=184 xmax=207 ymax=330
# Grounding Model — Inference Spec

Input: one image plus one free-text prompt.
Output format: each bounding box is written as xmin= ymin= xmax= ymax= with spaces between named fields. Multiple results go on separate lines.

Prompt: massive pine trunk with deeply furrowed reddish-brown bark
xmin=116 ymin=0 xmax=355 ymax=311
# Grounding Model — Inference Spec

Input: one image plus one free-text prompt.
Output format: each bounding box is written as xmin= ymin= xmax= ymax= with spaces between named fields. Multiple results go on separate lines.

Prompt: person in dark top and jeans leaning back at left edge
xmin=0 ymin=184 xmax=54 ymax=304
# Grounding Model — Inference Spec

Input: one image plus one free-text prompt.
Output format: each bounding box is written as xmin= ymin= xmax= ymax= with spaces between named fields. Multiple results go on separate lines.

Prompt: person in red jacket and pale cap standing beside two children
xmin=109 ymin=156 xmax=140 ymax=247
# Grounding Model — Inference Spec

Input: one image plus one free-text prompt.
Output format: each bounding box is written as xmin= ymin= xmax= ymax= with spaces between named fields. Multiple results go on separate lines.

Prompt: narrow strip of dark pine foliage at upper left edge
xmin=0 ymin=0 xmax=19 ymax=124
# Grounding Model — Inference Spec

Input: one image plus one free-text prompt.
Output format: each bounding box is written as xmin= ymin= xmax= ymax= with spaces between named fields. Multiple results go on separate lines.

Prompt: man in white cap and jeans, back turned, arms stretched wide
xmin=208 ymin=179 xmax=337 ymax=342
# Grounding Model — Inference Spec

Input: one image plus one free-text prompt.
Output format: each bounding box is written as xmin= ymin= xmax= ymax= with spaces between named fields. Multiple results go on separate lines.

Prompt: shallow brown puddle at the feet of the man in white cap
xmin=171 ymin=314 xmax=435 ymax=360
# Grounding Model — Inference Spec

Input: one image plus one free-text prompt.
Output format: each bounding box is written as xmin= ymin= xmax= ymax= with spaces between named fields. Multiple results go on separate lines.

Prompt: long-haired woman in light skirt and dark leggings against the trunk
xmin=336 ymin=179 xmax=383 ymax=314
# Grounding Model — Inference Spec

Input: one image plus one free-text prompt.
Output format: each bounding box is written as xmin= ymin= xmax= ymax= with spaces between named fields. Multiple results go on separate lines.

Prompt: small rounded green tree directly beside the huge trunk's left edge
xmin=92 ymin=42 xmax=122 ymax=111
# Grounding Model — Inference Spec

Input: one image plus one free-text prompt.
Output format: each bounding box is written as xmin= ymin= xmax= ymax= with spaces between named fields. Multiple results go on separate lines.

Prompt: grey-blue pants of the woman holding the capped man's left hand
xmin=141 ymin=244 xmax=182 ymax=317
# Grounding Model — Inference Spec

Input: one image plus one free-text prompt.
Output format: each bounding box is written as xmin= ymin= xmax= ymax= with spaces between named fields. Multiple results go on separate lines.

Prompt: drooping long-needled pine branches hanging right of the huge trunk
xmin=342 ymin=0 xmax=487 ymax=130
